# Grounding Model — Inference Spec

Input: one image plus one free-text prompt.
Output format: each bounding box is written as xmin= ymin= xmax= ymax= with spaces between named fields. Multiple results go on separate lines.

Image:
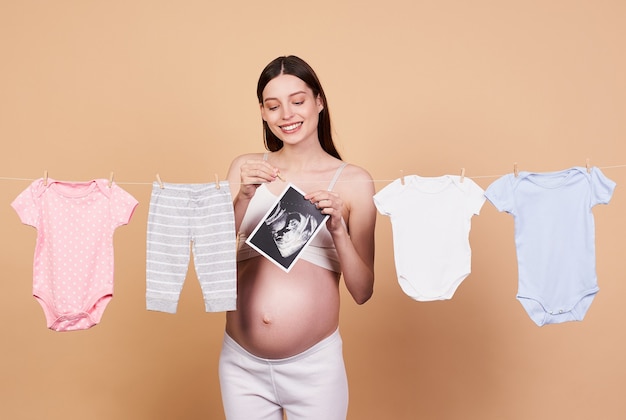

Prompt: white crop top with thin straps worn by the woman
xmin=237 ymin=153 xmax=346 ymax=273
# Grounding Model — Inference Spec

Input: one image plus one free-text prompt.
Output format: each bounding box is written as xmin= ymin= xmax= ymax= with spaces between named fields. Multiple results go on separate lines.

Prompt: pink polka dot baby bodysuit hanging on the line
xmin=11 ymin=178 xmax=138 ymax=331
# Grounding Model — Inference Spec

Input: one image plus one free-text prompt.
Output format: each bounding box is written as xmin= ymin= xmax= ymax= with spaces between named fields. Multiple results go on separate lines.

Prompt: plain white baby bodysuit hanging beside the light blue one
xmin=374 ymin=175 xmax=485 ymax=301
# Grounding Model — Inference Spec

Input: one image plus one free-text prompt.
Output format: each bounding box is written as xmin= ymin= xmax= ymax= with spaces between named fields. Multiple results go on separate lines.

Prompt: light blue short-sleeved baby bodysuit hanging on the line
xmin=485 ymin=167 xmax=616 ymax=326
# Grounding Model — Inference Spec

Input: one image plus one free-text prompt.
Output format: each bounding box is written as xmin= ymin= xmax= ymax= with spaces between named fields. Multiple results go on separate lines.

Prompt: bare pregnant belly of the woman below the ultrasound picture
xmin=226 ymin=257 xmax=339 ymax=359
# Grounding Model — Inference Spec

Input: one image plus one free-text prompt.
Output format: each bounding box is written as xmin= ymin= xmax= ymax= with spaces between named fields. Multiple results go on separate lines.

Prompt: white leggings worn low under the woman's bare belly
xmin=219 ymin=330 xmax=348 ymax=420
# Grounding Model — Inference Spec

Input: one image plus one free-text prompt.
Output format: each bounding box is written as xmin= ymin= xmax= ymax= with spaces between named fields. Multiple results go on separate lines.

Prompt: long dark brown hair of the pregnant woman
xmin=256 ymin=55 xmax=341 ymax=160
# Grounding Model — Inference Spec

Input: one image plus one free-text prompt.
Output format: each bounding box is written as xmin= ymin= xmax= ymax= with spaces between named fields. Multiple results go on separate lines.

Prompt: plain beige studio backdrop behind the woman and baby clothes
xmin=0 ymin=0 xmax=626 ymax=420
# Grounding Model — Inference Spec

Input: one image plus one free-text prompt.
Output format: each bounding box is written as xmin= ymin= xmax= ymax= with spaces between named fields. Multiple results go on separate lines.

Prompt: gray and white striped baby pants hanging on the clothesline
xmin=146 ymin=181 xmax=237 ymax=313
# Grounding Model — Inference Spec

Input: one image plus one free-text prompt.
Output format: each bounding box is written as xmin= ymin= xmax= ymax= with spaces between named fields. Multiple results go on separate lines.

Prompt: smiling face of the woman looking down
xmin=261 ymin=74 xmax=324 ymax=144
